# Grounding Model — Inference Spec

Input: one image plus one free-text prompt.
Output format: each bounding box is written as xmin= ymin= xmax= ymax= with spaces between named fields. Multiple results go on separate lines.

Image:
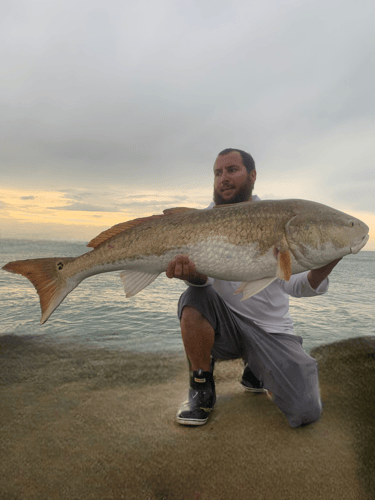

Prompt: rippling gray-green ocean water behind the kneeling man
xmin=0 ymin=239 xmax=375 ymax=354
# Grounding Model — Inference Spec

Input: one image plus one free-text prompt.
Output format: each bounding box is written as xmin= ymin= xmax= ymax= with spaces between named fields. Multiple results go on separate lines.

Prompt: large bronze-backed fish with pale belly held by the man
xmin=3 ymin=200 xmax=369 ymax=324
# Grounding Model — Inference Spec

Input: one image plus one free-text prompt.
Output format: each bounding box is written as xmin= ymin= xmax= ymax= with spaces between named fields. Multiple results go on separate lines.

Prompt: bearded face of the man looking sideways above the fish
xmin=214 ymin=151 xmax=256 ymax=205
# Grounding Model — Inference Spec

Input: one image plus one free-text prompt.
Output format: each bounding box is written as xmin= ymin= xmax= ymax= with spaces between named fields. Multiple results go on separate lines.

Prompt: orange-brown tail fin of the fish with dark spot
xmin=3 ymin=257 xmax=79 ymax=325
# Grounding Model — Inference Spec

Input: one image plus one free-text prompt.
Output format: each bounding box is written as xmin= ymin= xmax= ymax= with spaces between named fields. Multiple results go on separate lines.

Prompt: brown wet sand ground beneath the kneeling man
xmin=0 ymin=335 xmax=375 ymax=500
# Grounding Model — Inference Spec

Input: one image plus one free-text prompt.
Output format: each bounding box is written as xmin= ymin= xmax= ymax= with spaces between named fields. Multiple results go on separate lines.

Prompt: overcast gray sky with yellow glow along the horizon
xmin=0 ymin=0 xmax=375 ymax=250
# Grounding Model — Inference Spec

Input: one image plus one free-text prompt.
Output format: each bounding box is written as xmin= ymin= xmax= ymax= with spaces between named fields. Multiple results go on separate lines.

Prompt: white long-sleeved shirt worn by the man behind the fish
xmin=186 ymin=195 xmax=329 ymax=334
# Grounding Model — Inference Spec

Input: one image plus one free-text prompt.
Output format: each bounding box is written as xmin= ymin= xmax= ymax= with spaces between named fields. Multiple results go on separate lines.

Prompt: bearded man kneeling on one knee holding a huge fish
xmin=166 ymin=148 xmax=340 ymax=427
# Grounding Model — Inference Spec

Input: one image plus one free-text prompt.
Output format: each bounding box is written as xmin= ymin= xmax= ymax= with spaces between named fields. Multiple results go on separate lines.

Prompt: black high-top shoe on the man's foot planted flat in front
xmin=176 ymin=370 xmax=216 ymax=425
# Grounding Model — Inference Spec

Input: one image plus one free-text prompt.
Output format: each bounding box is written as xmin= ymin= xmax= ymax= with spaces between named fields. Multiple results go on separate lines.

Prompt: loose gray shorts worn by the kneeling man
xmin=178 ymin=286 xmax=322 ymax=427
